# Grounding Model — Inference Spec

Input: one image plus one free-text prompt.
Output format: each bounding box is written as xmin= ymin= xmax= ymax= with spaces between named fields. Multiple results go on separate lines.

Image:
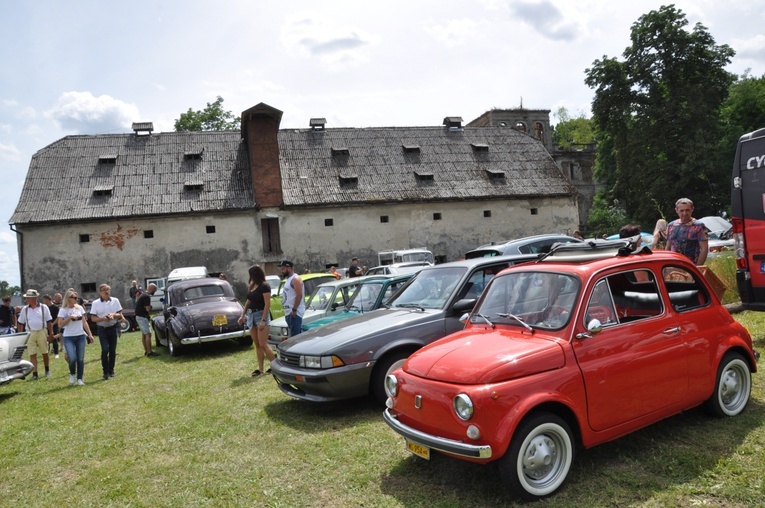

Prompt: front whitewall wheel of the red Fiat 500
xmin=499 ymin=413 xmax=574 ymax=501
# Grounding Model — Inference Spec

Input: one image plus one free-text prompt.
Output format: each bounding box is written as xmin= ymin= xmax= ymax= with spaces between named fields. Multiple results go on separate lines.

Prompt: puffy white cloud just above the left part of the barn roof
xmin=46 ymin=92 xmax=141 ymax=134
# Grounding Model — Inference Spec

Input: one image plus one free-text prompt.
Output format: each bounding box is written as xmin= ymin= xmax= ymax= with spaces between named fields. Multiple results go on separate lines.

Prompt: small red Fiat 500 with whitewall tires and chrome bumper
xmin=384 ymin=242 xmax=759 ymax=499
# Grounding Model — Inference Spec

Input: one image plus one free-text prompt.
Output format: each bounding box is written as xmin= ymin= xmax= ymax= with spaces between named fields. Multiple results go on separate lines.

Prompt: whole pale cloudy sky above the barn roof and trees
xmin=0 ymin=0 xmax=765 ymax=285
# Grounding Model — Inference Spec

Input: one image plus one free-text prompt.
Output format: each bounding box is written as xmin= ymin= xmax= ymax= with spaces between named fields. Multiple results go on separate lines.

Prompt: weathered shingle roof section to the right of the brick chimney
xmin=279 ymin=127 xmax=575 ymax=206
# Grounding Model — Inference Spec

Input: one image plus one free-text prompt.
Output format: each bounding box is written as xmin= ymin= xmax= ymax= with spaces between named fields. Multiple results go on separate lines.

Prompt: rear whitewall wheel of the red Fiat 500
xmin=706 ymin=352 xmax=752 ymax=417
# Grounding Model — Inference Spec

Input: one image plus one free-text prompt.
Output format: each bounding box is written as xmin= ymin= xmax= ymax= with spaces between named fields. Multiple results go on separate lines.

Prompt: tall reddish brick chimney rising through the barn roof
xmin=242 ymin=102 xmax=283 ymax=208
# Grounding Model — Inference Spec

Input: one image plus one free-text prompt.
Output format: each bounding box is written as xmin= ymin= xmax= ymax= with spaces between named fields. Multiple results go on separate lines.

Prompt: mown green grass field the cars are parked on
xmin=0 ymin=258 xmax=765 ymax=507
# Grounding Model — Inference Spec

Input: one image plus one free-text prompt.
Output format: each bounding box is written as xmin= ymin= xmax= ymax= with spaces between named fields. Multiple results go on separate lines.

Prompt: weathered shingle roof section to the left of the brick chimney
xmin=10 ymin=131 xmax=255 ymax=224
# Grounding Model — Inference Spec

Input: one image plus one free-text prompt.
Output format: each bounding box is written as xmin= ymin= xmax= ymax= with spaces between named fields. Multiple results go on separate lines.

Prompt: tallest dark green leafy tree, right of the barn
xmin=585 ymin=5 xmax=735 ymax=224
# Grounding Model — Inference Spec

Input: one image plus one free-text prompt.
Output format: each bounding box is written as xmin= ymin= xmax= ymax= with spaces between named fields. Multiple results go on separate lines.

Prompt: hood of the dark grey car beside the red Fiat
xmin=279 ymin=307 xmax=444 ymax=355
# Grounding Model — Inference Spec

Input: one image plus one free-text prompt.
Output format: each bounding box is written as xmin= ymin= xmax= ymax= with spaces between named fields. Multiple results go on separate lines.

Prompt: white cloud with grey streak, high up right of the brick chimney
xmin=281 ymin=14 xmax=373 ymax=65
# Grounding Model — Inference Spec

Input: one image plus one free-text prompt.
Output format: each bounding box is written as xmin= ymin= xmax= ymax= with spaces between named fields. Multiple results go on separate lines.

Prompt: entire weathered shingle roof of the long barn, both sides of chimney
xmin=10 ymin=121 xmax=576 ymax=224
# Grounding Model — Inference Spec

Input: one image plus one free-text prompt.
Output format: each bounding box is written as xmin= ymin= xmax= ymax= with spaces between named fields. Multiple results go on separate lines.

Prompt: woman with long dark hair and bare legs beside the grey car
xmin=239 ymin=265 xmax=274 ymax=377
